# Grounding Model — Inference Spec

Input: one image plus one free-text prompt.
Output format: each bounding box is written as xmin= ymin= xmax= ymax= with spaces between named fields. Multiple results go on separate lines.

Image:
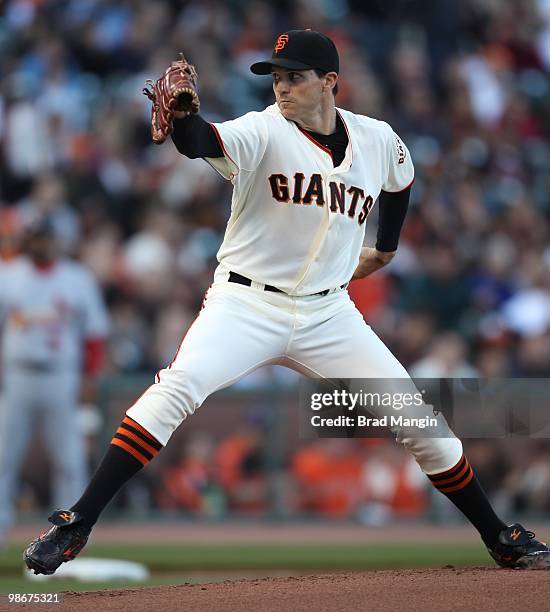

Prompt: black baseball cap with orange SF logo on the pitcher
xmin=250 ymin=30 xmax=340 ymax=74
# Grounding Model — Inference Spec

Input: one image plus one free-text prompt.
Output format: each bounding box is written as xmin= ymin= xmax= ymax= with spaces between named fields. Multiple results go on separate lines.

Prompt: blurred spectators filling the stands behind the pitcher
xmin=0 ymin=0 xmax=550 ymax=512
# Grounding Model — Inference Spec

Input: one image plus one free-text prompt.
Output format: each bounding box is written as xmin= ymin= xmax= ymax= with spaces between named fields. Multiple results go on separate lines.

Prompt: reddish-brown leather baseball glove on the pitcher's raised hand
xmin=143 ymin=53 xmax=200 ymax=144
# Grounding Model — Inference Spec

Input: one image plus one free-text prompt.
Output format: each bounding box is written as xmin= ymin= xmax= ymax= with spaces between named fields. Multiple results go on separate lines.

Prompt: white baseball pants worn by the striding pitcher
xmin=127 ymin=266 xmax=462 ymax=474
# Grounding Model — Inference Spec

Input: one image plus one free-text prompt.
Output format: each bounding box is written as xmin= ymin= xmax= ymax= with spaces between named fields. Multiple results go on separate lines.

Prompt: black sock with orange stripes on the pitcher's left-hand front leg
xmin=71 ymin=417 xmax=162 ymax=527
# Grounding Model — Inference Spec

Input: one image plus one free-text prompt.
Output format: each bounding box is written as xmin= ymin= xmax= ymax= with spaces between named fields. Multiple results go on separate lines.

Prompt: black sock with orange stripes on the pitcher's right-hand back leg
xmin=428 ymin=455 xmax=506 ymax=548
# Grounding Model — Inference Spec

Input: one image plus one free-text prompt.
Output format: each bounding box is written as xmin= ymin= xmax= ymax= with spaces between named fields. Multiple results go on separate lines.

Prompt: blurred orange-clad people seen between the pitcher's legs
xmin=151 ymin=426 xmax=430 ymax=524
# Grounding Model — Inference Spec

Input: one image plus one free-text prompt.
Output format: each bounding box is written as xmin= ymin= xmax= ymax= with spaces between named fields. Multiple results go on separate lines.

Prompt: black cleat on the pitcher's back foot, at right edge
xmin=487 ymin=523 xmax=550 ymax=569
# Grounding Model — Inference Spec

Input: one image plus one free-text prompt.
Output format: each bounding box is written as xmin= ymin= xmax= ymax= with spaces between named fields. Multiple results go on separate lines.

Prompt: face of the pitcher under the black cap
xmin=271 ymin=66 xmax=324 ymax=122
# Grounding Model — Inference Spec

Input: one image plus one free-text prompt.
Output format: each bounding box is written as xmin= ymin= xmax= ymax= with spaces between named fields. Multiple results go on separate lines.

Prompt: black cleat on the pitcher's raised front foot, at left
xmin=23 ymin=510 xmax=91 ymax=575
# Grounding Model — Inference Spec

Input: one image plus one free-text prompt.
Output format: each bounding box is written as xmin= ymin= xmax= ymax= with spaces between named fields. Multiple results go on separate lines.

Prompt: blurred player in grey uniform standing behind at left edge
xmin=0 ymin=221 xmax=109 ymax=548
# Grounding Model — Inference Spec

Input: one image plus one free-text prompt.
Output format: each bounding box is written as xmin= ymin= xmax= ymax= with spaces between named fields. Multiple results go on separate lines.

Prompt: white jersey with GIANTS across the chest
xmin=207 ymin=104 xmax=414 ymax=296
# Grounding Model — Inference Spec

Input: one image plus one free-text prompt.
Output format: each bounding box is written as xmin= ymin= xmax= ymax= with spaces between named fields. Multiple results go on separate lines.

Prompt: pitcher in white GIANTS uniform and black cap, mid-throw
xmin=25 ymin=30 xmax=550 ymax=573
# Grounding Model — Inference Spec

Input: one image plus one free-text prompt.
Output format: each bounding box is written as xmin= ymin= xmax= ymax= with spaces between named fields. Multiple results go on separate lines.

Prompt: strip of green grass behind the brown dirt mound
xmin=0 ymin=542 xmax=491 ymax=593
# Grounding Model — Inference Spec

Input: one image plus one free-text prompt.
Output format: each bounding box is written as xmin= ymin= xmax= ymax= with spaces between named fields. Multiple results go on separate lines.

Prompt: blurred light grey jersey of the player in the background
xmin=0 ymin=259 xmax=109 ymax=371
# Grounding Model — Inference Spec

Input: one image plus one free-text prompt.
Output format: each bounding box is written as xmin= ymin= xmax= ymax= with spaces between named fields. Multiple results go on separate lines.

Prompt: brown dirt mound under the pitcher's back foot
xmin=9 ymin=568 xmax=550 ymax=612
